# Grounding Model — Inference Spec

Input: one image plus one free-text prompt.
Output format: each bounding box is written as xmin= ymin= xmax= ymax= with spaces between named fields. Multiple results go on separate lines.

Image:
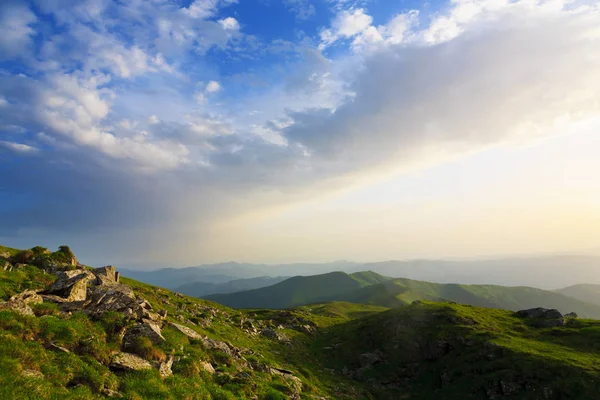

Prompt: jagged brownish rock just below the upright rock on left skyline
xmin=84 ymin=283 xmax=138 ymax=318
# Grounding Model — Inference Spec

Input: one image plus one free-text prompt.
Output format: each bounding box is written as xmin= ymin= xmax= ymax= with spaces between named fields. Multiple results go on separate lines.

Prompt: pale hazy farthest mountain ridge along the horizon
xmin=121 ymin=255 xmax=600 ymax=290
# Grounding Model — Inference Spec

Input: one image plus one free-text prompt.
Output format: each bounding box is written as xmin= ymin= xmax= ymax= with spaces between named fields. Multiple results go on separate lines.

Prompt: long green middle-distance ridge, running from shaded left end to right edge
xmin=207 ymin=272 xmax=600 ymax=318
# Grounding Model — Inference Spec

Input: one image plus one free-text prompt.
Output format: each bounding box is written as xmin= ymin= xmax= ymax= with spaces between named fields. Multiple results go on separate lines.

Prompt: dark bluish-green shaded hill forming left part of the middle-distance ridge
xmin=204 ymin=271 xmax=389 ymax=309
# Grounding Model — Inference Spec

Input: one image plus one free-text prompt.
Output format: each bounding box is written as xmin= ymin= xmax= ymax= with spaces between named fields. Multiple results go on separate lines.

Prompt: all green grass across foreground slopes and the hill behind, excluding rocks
xmin=0 ymin=245 xmax=600 ymax=400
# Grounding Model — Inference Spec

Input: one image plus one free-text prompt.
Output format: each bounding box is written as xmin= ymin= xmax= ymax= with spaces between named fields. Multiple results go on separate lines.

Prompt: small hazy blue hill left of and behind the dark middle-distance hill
xmin=173 ymin=276 xmax=289 ymax=297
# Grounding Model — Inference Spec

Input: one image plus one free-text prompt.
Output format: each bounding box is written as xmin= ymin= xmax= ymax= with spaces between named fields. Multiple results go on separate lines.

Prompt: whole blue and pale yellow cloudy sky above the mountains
xmin=0 ymin=0 xmax=600 ymax=266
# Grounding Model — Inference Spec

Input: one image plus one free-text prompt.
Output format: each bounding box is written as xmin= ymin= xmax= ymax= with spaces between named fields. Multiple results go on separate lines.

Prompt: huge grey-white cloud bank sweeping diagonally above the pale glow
xmin=0 ymin=1 xmax=600 ymax=261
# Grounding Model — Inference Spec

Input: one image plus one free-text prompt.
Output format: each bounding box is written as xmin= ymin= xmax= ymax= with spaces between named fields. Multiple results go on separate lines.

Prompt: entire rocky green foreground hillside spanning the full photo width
xmin=0 ymin=247 xmax=600 ymax=400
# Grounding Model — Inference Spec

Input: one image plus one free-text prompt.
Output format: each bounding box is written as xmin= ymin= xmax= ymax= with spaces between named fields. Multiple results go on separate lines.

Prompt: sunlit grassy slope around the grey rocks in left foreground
xmin=0 ymin=266 xmax=382 ymax=400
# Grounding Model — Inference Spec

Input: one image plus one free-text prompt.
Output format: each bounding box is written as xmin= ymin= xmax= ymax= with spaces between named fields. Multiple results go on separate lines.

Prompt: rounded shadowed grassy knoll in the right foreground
xmin=314 ymin=303 xmax=600 ymax=400
